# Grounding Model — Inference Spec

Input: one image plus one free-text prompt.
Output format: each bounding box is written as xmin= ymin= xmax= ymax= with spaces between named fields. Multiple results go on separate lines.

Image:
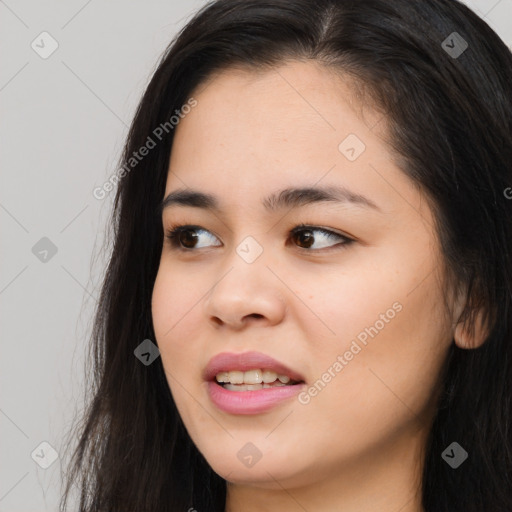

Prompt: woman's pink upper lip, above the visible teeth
xmin=203 ymin=352 xmax=304 ymax=382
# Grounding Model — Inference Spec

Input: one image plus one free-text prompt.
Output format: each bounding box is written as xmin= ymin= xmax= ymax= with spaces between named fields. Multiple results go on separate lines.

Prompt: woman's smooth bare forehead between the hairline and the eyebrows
xmin=166 ymin=61 xmax=412 ymax=216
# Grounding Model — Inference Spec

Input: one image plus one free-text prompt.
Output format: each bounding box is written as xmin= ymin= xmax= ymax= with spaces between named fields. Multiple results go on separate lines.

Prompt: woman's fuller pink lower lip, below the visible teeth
xmin=208 ymin=382 xmax=305 ymax=414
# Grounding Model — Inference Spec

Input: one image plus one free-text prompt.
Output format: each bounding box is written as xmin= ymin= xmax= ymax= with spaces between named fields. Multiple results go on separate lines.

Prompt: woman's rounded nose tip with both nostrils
xmin=203 ymin=255 xmax=286 ymax=331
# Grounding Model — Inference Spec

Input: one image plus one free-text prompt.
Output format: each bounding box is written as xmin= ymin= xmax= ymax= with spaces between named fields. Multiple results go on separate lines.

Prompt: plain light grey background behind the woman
xmin=0 ymin=0 xmax=512 ymax=512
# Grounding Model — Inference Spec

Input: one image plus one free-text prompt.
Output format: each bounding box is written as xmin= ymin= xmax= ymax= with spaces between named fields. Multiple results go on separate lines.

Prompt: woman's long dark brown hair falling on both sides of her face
xmin=61 ymin=0 xmax=512 ymax=512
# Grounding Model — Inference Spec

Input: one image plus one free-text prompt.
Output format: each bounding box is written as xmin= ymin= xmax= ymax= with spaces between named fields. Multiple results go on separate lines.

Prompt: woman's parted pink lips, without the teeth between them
xmin=203 ymin=352 xmax=305 ymax=414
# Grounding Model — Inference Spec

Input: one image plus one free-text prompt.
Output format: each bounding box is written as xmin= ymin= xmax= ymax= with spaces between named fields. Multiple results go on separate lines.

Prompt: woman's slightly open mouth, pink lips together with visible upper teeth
xmin=203 ymin=352 xmax=305 ymax=414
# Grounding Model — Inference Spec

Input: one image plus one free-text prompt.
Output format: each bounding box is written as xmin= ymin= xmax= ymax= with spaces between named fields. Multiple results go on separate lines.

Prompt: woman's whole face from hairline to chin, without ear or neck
xmin=152 ymin=62 xmax=453 ymax=488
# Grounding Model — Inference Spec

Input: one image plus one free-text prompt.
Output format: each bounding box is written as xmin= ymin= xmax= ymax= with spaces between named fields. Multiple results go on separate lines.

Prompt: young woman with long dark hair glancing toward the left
xmin=59 ymin=0 xmax=512 ymax=512
